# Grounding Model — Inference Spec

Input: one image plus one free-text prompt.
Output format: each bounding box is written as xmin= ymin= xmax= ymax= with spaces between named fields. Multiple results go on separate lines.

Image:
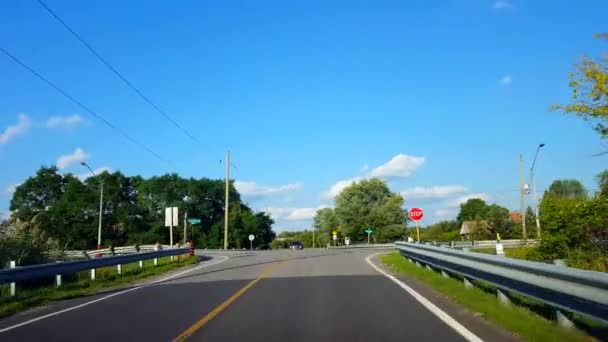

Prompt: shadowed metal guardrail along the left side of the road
xmin=0 ymin=248 xmax=190 ymax=284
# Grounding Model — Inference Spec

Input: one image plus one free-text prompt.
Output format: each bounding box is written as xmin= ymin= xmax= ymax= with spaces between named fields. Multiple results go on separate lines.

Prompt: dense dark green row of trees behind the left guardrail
xmin=10 ymin=167 xmax=275 ymax=249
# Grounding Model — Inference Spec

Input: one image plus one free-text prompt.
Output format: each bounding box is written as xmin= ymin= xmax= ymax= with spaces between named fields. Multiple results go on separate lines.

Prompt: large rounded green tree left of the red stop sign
xmin=334 ymin=178 xmax=405 ymax=242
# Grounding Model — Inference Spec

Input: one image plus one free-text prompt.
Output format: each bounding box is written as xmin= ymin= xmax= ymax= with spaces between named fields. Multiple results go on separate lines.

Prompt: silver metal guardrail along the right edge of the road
xmin=395 ymin=242 xmax=608 ymax=321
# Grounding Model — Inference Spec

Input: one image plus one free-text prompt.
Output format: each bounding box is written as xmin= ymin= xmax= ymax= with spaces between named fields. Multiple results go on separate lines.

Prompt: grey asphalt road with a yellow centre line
xmin=0 ymin=249 xmax=508 ymax=341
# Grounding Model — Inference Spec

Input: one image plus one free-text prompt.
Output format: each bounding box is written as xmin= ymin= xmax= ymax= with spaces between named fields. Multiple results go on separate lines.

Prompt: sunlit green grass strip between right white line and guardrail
xmin=380 ymin=253 xmax=593 ymax=341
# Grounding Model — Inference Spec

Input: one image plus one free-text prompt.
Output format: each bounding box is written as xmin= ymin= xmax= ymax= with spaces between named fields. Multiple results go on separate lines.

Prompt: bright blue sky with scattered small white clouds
xmin=0 ymin=0 xmax=608 ymax=230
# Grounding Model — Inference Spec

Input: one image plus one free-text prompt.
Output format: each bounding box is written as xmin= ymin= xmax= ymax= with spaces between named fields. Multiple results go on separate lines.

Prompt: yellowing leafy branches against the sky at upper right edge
xmin=552 ymin=33 xmax=608 ymax=139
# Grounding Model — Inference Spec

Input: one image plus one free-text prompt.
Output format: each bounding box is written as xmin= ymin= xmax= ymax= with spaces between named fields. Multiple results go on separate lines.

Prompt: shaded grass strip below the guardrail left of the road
xmin=0 ymin=256 xmax=198 ymax=318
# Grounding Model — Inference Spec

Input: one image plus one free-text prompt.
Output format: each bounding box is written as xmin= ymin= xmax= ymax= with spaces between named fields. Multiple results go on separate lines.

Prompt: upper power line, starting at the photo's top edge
xmin=37 ymin=0 xmax=236 ymax=169
